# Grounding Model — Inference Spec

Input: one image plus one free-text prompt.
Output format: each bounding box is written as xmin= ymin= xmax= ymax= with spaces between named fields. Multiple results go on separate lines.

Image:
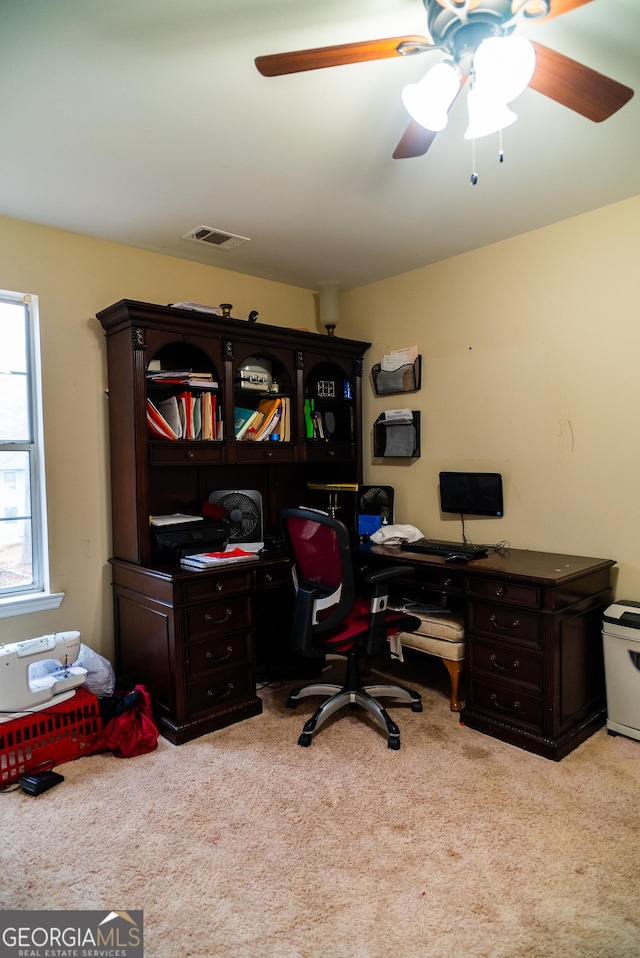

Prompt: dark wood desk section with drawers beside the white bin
xmin=362 ymin=546 xmax=615 ymax=761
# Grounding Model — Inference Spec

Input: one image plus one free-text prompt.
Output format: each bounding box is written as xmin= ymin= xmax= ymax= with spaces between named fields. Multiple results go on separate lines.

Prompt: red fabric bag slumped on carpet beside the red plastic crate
xmin=90 ymin=685 xmax=160 ymax=758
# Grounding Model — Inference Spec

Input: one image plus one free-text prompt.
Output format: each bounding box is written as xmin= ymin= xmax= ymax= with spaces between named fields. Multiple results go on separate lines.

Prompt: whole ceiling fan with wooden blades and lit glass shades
xmin=255 ymin=0 xmax=633 ymax=163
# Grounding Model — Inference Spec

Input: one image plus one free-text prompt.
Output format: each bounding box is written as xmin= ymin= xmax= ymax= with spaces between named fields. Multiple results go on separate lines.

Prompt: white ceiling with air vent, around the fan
xmin=0 ymin=0 xmax=640 ymax=289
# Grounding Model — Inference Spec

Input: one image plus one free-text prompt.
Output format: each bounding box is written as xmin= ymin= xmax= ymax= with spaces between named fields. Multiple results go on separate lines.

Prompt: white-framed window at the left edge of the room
xmin=0 ymin=290 xmax=62 ymax=617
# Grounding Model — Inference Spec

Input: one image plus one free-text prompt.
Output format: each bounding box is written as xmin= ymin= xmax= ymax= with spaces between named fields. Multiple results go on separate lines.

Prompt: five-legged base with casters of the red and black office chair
xmin=287 ymin=651 xmax=422 ymax=750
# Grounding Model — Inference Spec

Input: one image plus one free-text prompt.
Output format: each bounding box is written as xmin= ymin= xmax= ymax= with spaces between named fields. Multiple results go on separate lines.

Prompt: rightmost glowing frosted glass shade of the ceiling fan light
xmin=473 ymin=34 xmax=536 ymax=103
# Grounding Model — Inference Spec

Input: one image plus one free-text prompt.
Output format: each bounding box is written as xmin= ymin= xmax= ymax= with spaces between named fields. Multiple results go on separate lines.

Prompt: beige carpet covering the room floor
xmin=0 ymin=661 xmax=640 ymax=958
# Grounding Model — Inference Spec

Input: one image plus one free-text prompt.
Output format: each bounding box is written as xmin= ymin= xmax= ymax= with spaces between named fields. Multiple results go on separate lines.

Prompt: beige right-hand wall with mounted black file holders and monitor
xmin=340 ymin=197 xmax=640 ymax=599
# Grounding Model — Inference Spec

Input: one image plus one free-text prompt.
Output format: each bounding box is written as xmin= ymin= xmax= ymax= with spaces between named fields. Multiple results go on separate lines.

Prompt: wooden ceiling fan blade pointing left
xmin=255 ymin=36 xmax=433 ymax=77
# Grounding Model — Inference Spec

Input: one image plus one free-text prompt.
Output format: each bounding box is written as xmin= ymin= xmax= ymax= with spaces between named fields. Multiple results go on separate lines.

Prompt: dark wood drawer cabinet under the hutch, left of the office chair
xmin=111 ymin=555 xmax=291 ymax=745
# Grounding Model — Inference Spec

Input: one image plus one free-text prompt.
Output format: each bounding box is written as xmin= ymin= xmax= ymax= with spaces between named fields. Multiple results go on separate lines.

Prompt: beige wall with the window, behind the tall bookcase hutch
xmin=0 ymin=218 xmax=317 ymax=657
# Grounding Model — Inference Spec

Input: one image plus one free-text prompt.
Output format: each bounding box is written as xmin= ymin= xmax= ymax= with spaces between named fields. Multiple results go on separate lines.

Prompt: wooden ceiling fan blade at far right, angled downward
xmin=529 ymin=43 xmax=633 ymax=123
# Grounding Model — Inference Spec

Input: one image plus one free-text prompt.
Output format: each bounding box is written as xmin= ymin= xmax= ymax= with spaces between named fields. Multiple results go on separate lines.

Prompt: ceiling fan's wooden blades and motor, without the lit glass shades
xmin=255 ymin=0 xmax=633 ymax=159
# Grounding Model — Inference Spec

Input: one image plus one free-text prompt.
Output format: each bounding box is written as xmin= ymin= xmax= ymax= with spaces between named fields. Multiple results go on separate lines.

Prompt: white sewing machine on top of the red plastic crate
xmin=0 ymin=632 xmax=87 ymax=723
